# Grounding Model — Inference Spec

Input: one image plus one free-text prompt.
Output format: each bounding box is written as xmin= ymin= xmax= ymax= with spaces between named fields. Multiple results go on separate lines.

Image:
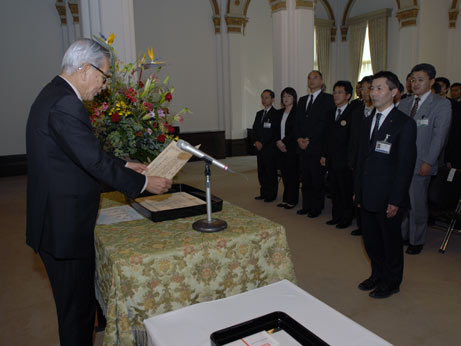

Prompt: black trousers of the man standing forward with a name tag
xmin=360 ymin=206 xmax=403 ymax=287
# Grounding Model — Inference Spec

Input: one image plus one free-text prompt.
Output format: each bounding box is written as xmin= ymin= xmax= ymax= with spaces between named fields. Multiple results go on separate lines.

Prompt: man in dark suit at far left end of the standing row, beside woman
xmin=253 ymin=89 xmax=278 ymax=203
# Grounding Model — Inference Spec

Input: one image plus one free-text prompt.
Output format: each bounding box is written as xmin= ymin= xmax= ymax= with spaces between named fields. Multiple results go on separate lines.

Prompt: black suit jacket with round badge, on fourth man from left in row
xmin=323 ymin=105 xmax=353 ymax=169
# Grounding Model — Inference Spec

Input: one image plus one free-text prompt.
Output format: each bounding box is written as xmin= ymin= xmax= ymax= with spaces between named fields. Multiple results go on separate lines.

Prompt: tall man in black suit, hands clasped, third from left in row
xmin=296 ymin=71 xmax=335 ymax=218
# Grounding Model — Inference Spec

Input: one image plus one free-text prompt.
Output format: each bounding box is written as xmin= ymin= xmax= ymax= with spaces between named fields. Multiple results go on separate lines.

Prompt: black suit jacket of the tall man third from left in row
xmin=295 ymin=92 xmax=335 ymax=156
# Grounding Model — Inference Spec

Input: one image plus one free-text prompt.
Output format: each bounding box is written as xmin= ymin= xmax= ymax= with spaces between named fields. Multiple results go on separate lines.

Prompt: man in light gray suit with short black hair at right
xmin=399 ymin=64 xmax=451 ymax=255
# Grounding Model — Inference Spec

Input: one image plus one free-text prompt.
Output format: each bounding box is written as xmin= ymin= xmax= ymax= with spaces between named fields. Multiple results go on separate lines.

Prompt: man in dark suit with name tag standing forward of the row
xmin=354 ymin=71 xmax=416 ymax=298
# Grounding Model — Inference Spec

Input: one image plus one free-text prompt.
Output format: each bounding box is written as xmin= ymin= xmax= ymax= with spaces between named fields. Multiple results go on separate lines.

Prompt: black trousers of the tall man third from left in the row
xmin=300 ymin=153 xmax=325 ymax=212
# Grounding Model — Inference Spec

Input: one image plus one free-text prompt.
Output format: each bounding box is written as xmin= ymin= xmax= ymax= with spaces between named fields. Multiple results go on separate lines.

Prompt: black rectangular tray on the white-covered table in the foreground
xmin=210 ymin=311 xmax=329 ymax=346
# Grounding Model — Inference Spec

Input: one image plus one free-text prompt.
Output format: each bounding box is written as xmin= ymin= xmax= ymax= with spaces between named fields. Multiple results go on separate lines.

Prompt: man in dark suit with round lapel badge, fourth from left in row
xmin=321 ymin=81 xmax=354 ymax=229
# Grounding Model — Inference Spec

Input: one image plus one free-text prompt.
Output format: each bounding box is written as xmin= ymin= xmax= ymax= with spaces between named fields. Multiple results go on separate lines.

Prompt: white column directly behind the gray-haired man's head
xmin=77 ymin=0 xmax=137 ymax=63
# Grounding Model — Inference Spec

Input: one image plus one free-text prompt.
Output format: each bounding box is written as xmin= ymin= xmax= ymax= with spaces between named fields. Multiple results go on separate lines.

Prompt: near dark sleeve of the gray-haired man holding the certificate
xmin=48 ymin=96 xmax=146 ymax=198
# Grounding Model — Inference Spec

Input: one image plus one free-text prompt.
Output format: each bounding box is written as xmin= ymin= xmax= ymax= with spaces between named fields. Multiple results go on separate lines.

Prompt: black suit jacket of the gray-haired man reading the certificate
xmin=26 ymin=76 xmax=145 ymax=258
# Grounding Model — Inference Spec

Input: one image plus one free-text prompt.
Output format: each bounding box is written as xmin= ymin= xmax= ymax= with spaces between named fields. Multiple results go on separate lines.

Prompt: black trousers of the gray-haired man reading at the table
xmin=40 ymin=251 xmax=96 ymax=346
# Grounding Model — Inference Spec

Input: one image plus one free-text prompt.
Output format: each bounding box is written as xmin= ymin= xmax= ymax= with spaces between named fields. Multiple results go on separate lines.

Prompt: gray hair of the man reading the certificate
xmin=61 ymin=38 xmax=110 ymax=75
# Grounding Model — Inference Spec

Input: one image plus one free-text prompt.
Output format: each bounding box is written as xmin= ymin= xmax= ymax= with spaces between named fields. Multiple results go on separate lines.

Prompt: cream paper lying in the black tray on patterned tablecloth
xmin=135 ymin=192 xmax=205 ymax=212
